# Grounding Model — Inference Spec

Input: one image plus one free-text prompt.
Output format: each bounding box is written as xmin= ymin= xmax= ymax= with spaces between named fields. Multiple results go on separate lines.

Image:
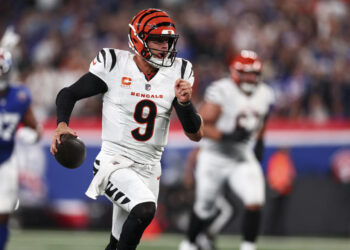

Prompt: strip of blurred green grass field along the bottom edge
xmin=7 ymin=230 xmax=350 ymax=250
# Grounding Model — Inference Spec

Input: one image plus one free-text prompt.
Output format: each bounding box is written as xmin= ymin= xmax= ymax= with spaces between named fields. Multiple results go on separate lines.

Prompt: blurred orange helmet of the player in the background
xmin=230 ymin=50 xmax=262 ymax=94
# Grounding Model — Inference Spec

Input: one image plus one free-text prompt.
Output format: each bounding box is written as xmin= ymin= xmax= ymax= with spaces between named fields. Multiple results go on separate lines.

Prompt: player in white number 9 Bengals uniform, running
xmin=51 ymin=9 xmax=203 ymax=250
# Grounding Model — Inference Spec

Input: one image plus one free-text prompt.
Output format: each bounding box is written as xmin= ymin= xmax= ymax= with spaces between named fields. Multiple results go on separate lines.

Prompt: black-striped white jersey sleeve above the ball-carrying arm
xmin=89 ymin=48 xmax=117 ymax=82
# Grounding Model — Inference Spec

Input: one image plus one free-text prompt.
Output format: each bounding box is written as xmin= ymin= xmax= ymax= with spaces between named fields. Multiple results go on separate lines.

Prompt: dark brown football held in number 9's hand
xmin=55 ymin=134 xmax=86 ymax=169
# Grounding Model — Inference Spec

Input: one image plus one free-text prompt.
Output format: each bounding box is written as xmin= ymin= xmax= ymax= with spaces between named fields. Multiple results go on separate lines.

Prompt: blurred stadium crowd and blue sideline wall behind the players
xmin=0 ymin=0 xmax=350 ymax=248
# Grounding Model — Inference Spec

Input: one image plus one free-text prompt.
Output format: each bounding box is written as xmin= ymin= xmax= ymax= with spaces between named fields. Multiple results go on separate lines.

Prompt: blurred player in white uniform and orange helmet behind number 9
xmin=180 ymin=50 xmax=274 ymax=250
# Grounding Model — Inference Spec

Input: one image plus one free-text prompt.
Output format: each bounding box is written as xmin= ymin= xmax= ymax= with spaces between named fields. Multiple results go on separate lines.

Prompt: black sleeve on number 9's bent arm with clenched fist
xmin=173 ymin=98 xmax=202 ymax=134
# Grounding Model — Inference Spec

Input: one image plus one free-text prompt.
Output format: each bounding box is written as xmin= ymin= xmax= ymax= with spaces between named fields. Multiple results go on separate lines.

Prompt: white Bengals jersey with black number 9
xmin=90 ymin=49 xmax=194 ymax=164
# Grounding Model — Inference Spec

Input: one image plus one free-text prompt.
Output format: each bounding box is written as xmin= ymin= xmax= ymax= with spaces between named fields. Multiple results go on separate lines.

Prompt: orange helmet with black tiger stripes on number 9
xmin=128 ymin=9 xmax=179 ymax=68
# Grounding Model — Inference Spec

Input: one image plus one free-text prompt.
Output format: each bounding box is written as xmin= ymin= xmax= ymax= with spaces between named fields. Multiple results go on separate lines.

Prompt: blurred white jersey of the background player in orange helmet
xmin=200 ymin=78 xmax=274 ymax=158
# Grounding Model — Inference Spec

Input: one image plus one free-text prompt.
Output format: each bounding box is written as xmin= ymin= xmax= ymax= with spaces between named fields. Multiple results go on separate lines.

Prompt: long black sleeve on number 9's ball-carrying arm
xmin=56 ymin=72 xmax=108 ymax=124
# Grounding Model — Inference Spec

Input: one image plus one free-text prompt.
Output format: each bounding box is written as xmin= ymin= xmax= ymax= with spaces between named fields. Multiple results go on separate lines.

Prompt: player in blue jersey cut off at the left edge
xmin=0 ymin=48 xmax=40 ymax=250
